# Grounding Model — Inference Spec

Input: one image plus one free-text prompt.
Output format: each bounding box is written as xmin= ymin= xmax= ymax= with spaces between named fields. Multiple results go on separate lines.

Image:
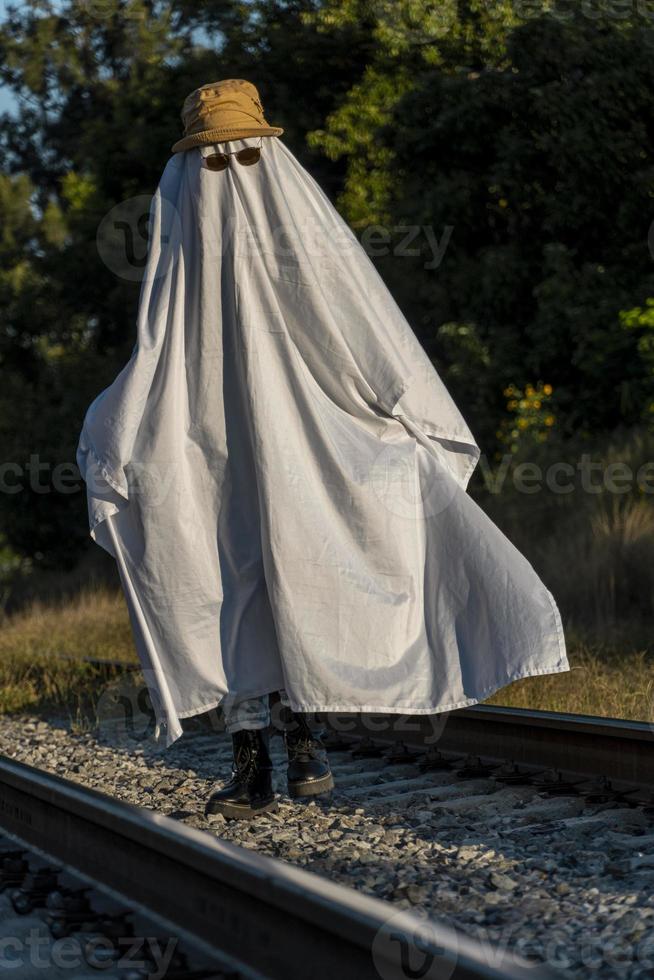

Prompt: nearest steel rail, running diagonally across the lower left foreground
xmin=0 ymin=757 xmax=555 ymax=980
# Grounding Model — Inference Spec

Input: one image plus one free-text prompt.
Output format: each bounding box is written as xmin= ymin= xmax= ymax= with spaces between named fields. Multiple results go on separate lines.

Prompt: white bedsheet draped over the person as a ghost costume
xmin=77 ymin=138 xmax=569 ymax=745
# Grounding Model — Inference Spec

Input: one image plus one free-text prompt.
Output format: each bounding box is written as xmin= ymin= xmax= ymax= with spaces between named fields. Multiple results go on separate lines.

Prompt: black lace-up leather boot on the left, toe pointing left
xmin=204 ymin=729 xmax=277 ymax=820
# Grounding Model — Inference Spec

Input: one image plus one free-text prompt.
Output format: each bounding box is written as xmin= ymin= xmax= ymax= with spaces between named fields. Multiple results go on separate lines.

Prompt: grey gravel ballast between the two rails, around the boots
xmin=0 ymin=716 xmax=654 ymax=980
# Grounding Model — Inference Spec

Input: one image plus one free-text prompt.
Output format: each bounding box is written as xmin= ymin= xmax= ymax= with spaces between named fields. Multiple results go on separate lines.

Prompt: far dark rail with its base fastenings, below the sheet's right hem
xmin=316 ymin=705 xmax=654 ymax=812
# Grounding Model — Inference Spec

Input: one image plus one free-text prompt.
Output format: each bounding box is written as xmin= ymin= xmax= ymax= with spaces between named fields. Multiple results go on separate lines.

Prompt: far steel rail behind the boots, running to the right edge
xmin=316 ymin=705 xmax=654 ymax=794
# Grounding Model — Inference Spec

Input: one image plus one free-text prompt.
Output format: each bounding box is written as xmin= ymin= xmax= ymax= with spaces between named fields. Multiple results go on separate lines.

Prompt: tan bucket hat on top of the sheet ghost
xmin=172 ymin=78 xmax=284 ymax=153
